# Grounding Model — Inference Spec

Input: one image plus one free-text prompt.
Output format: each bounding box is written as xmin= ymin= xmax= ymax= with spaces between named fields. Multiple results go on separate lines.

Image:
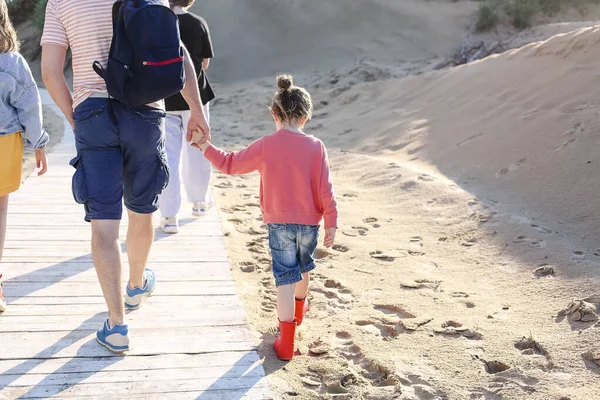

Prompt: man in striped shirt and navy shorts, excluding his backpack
xmin=41 ymin=0 xmax=210 ymax=353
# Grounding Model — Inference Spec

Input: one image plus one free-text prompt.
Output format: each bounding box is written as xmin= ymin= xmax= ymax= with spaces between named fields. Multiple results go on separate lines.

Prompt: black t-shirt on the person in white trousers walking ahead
xmin=165 ymin=13 xmax=215 ymax=111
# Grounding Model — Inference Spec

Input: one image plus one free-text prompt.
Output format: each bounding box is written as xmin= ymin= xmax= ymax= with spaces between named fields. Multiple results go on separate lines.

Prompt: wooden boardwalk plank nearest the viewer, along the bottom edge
xmin=0 ymin=377 xmax=272 ymax=400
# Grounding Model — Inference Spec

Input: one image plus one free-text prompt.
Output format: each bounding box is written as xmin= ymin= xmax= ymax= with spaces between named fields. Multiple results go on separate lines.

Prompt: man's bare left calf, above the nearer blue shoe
xmin=92 ymin=220 xmax=125 ymax=327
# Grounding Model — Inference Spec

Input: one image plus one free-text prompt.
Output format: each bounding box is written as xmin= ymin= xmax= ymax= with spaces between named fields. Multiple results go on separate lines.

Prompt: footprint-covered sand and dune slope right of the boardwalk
xmin=200 ymin=20 xmax=600 ymax=400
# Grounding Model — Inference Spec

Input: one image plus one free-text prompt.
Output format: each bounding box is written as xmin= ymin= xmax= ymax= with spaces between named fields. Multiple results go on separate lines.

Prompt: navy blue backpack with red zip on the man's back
xmin=90 ymin=0 xmax=185 ymax=107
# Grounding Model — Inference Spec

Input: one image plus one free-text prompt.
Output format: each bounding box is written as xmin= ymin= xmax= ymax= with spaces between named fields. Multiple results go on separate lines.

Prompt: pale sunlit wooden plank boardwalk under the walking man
xmin=0 ymin=92 xmax=271 ymax=400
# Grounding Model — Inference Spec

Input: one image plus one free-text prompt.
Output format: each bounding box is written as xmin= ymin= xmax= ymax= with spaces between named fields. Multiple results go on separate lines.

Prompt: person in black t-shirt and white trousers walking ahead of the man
xmin=159 ymin=0 xmax=215 ymax=233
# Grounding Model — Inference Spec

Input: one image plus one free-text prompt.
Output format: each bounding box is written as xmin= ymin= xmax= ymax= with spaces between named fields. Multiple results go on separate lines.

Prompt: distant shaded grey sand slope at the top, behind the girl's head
xmin=193 ymin=0 xmax=477 ymax=82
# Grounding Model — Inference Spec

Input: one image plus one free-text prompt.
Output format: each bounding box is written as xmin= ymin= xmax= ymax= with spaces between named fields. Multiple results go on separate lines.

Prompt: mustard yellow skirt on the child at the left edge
xmin=0 ymin=132 xmax=23 ymax=196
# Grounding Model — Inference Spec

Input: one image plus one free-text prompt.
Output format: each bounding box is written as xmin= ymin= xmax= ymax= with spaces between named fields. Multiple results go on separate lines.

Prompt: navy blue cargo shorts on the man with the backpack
xmin=71 ymin=98 xmax=169 ymax=221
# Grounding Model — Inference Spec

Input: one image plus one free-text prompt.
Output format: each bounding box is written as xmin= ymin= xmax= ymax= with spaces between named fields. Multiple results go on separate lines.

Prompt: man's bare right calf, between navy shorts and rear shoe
xmin=127 ymin=210 xmax=154 ymax=289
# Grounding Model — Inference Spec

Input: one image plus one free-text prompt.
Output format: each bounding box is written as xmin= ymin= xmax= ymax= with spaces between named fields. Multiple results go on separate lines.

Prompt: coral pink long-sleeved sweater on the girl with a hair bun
xmin=204 ymin=129 xmax=338 ymax=229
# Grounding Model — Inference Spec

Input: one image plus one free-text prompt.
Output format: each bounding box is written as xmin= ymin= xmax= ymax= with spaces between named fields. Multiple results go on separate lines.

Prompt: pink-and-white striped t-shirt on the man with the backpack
xmin=41 ymin=0 xmax=168 ymax=108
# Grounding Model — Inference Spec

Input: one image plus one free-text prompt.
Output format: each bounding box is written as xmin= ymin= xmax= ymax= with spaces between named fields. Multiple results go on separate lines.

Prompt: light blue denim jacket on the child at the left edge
xmin=0 ymin=52 xmax=48 ymax=150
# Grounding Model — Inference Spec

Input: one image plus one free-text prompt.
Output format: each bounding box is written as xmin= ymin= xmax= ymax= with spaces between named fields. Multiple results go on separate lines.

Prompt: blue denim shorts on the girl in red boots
xmin=268 ymin=224 xmax=319 ymax=286
